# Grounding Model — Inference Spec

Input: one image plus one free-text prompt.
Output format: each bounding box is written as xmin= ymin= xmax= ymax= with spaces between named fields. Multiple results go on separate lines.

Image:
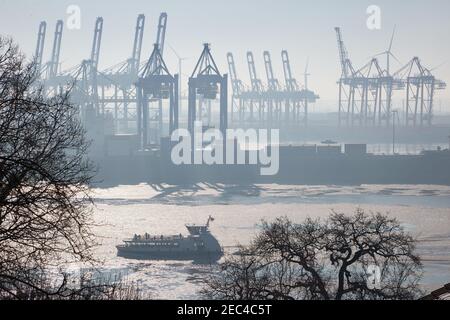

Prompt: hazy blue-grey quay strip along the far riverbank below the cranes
xmin=91 ymin=136 xmax=450 ymax=186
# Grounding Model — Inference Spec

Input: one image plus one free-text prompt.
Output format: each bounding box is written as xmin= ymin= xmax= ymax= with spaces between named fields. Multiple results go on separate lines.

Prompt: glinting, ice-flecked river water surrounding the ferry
xmin=88 ymin=184 xmax=450 ymax=299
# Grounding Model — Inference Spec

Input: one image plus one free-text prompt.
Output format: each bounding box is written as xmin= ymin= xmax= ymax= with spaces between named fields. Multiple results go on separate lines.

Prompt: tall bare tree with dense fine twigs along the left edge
xmin=0 ymin=37 xmax=118 ymax=299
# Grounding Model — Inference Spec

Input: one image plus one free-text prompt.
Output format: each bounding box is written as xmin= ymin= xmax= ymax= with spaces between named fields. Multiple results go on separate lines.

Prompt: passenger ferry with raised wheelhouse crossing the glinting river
xmin=116 ymin=216 xmax=223 ymax=262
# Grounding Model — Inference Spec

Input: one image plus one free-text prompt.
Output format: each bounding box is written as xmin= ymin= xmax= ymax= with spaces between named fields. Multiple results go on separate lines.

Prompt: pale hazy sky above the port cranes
xmin=0 ymin=0 xmax=450 ymax=110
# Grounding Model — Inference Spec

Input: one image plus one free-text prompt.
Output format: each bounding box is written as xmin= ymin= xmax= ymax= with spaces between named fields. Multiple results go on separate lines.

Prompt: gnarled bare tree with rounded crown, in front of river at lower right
xmin=203 ymin=209 xmax=422 ymax=300
